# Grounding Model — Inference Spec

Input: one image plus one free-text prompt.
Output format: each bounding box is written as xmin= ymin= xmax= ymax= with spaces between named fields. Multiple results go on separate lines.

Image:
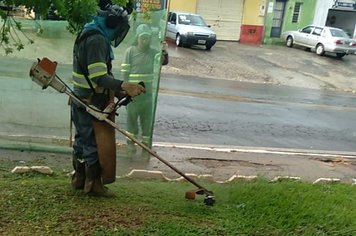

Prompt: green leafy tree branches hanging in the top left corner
xmin=0 ymin=0 xmax=129 ymax=54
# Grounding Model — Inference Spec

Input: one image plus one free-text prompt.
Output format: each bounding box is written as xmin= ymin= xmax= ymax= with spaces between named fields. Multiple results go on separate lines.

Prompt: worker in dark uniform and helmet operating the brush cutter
xmin=71 ymin=1 xmax=145 ymax=196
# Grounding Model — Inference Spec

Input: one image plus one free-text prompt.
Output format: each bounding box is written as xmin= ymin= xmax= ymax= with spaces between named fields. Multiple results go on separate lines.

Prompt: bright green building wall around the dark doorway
xmin=264 ymin=0 xmax=317 ymax=44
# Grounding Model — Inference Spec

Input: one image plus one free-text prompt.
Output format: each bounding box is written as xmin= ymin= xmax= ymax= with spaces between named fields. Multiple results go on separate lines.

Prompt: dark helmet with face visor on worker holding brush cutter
xmin=98 ymin=2 xmax=130 ymax=47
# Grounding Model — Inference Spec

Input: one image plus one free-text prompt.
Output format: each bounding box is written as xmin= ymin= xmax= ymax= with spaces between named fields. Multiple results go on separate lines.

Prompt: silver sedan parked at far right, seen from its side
xmin=281 ymin=25 xmax=356 ymax=58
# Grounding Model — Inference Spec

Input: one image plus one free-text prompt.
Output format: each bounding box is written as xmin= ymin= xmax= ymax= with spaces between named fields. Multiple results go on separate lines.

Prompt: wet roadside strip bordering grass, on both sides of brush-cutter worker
xmin=0 ymin=143 xmax=356 ymax=183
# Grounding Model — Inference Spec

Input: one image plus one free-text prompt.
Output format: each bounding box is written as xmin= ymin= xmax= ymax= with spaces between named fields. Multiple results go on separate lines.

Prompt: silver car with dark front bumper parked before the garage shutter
xmin=166 ymin=12 xmax=216 ymax=50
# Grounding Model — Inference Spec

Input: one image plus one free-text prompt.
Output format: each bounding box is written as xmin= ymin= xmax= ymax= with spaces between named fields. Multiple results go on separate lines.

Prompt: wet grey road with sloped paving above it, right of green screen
xmin=155 ymin=42 xmax=356 ymax=152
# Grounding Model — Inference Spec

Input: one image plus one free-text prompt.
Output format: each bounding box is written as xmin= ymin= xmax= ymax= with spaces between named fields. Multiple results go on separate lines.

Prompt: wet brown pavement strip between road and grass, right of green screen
xmin=148 ymin=144 xmax=356 ymax=183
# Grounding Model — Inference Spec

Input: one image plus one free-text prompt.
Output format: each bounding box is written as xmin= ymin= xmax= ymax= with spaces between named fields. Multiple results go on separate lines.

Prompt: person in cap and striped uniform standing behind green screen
xmin=121 ymin=24 xmax=168 ymax=153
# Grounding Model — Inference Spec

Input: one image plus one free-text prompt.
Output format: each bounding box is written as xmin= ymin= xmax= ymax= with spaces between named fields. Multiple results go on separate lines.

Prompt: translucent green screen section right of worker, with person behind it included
xmin=119 ymin=9 xmax=167 ymax=151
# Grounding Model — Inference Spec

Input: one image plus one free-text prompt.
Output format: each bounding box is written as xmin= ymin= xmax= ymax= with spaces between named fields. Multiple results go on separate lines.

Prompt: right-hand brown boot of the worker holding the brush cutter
xmin=84 ymin=162 xmax=115 ymax=197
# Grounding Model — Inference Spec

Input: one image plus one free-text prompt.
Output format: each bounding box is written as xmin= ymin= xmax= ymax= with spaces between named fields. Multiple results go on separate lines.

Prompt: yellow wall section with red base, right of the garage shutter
xmin=240 ymin=0 xmax=266 ymax=44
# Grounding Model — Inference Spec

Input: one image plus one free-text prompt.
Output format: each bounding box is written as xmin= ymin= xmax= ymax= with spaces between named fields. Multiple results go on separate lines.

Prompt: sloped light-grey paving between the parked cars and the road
xmin=162 ymin=42 xmax=356 ymax=92
